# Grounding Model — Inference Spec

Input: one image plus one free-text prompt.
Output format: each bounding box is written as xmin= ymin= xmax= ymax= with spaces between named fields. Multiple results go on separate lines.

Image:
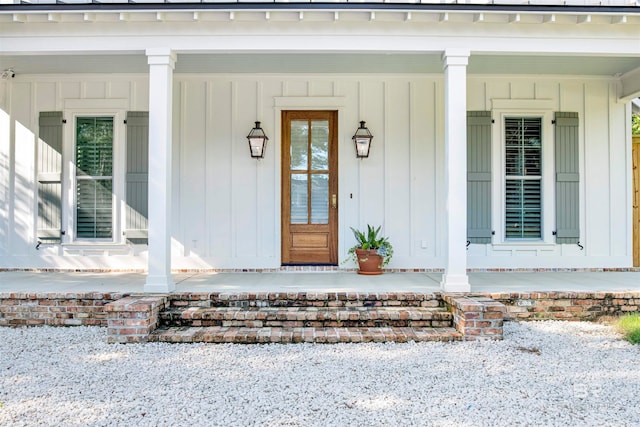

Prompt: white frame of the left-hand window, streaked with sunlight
xmin=62 ymin=108 xmax=126 ymax=246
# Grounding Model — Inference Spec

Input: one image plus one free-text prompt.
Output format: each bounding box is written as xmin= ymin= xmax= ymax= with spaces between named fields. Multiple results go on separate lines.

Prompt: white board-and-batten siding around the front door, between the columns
xmin=173 ymin=76 xmax=442 ymax=268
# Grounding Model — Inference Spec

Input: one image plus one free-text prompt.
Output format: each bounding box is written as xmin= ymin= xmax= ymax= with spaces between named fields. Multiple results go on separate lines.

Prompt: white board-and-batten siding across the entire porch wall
xmin=0 ymin=74 xmax=631 ymax=269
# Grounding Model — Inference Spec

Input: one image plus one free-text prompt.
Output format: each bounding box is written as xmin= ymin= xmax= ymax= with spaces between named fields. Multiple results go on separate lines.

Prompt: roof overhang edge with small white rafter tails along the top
xmin=0 ymin=0 xmax=640 ymax=24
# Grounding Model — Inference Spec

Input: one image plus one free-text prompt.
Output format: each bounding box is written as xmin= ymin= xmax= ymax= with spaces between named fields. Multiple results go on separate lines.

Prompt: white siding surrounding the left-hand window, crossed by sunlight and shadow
xmin=0 ymin=75 xmax=148 ymax=268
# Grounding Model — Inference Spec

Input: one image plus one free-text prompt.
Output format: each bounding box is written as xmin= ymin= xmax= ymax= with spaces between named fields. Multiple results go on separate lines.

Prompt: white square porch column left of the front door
xmin=144 ymin=48 xmax=176 ymax=292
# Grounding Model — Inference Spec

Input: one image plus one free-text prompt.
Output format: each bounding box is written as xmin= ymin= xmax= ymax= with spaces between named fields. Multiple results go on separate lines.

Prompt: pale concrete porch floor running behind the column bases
xmin=0 ymin=271 xmax=640 ymax=293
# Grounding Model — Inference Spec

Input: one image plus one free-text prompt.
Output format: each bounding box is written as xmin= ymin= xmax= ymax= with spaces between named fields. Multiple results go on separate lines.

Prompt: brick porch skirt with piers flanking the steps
xmin=0 ymin=292 xmax=640 ymax=342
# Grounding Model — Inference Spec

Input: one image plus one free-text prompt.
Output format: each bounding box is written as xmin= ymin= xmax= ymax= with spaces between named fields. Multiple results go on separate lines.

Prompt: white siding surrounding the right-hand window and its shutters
xmin=468 ymin=76 xmax=632 ymax=269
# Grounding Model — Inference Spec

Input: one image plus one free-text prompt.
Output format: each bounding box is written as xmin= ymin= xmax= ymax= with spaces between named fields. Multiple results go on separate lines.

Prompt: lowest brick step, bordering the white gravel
xmin=149 ymin=326 xmax=462 ymax=344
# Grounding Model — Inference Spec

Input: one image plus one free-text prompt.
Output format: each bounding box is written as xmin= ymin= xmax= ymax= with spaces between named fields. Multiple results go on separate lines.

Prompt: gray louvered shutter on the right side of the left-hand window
xmin=125 ymin=111 xmax=149 ymax=243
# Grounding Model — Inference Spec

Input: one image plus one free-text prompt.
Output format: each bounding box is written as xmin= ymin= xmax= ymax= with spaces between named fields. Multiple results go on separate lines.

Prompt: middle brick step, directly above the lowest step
xmin=160 ymin=307 xmax=453 ymax=328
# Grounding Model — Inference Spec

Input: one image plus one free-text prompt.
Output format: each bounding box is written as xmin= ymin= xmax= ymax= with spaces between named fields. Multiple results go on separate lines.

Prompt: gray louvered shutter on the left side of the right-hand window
xmin=467 ymin=111 xmax=492 ymax=243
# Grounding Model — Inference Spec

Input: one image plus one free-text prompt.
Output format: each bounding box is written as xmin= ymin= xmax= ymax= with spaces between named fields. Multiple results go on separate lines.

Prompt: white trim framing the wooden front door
xmin=273 ymin=96 xmax=346 ymax=266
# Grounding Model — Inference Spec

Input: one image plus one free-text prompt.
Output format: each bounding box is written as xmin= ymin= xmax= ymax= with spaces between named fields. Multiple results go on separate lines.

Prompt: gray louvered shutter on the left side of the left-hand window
xmin=36 ymin=111 xmax=63 ymax=243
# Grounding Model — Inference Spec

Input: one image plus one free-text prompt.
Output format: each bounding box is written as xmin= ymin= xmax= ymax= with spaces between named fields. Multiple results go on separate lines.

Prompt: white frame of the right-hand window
xmin=491 ymin=100 xmax=555 ymax=246
